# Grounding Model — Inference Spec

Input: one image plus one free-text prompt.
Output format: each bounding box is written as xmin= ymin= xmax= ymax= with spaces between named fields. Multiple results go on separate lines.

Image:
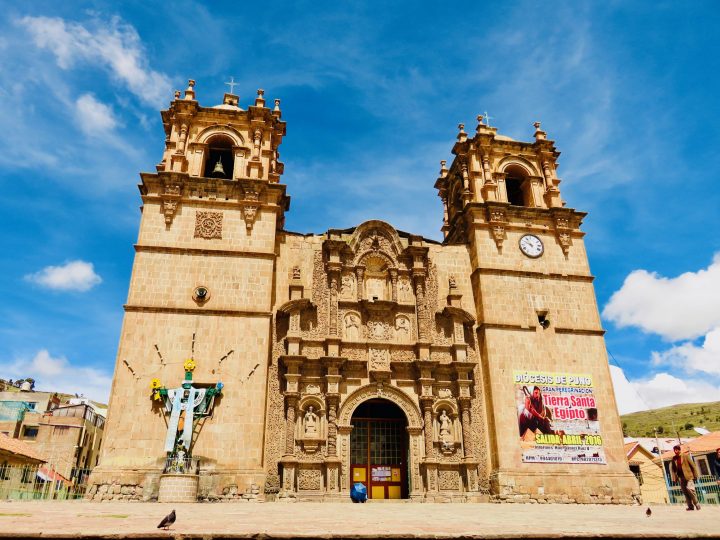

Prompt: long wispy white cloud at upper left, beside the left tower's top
xmin=19 ymin=16 xmax=172 ymax=107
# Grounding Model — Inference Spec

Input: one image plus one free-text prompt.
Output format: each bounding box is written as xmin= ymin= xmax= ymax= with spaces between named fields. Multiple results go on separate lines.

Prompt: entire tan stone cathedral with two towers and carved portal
xmin=88 ymin=81 xmax=637 ymax=503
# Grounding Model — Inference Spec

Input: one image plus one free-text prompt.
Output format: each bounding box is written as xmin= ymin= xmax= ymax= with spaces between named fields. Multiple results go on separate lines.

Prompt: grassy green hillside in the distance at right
xmin=620 ymin=401 xmax=720 ymax=437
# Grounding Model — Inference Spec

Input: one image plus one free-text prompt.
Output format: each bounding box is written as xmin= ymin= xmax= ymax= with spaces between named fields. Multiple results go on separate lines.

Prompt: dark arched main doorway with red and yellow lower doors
xmin=350 ymin=399 xmax=410 ymax=499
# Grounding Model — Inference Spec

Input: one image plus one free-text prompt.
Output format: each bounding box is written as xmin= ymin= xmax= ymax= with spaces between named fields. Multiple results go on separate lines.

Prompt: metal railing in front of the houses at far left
xmin=0 ymin=464 xmax=91 ymax=500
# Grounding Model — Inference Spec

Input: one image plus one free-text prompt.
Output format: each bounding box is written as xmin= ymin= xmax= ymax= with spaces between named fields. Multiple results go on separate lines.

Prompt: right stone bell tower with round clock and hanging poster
xmin=435 ymin=116 xmax=636 ymax=502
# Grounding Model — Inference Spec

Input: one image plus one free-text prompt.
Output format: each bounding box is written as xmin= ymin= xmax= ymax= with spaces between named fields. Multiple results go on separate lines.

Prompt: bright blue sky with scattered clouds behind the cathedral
xmin=0 ymin=0 xmax=720 ymax=411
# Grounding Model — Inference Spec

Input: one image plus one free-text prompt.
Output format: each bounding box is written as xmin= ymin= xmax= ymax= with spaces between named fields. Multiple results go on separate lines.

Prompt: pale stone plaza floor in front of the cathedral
xmin=0 ymin=501 xmax=720 ymax=539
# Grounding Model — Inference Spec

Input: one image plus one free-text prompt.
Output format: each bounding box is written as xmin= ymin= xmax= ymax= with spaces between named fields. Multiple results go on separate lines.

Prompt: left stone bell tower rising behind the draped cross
xmin=89 ymin=80 xmax=289 ymax=499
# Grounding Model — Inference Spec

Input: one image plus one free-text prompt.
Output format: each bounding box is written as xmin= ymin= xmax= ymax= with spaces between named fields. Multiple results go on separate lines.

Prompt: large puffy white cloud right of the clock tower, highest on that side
xmin=603 ymin=253 xmax=720 ymax=341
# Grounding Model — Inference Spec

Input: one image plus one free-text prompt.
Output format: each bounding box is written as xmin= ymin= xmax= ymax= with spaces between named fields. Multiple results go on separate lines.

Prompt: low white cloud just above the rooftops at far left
xmin=4 ymin=349 xmax=112 ymax=403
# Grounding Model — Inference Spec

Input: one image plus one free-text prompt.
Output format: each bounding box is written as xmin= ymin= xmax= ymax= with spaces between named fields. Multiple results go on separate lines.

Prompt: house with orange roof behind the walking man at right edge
xmin=660 ymin=431 xmax=720 ymax=504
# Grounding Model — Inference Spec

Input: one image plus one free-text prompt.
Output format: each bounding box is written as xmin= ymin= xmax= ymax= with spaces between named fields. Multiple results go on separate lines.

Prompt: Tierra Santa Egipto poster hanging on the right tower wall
xmin=513 ymin=371 xmax=606 ymax=464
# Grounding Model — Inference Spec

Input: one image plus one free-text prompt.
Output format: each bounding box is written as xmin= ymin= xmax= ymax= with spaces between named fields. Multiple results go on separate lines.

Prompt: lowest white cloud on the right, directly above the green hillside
xmin=610 ymin=366 xmax=720 ymax=414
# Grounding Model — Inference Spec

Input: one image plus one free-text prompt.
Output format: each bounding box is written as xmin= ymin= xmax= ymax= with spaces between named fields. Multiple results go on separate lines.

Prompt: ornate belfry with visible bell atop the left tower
xmin=148 ymin=80 xmax=290 ymax=230
